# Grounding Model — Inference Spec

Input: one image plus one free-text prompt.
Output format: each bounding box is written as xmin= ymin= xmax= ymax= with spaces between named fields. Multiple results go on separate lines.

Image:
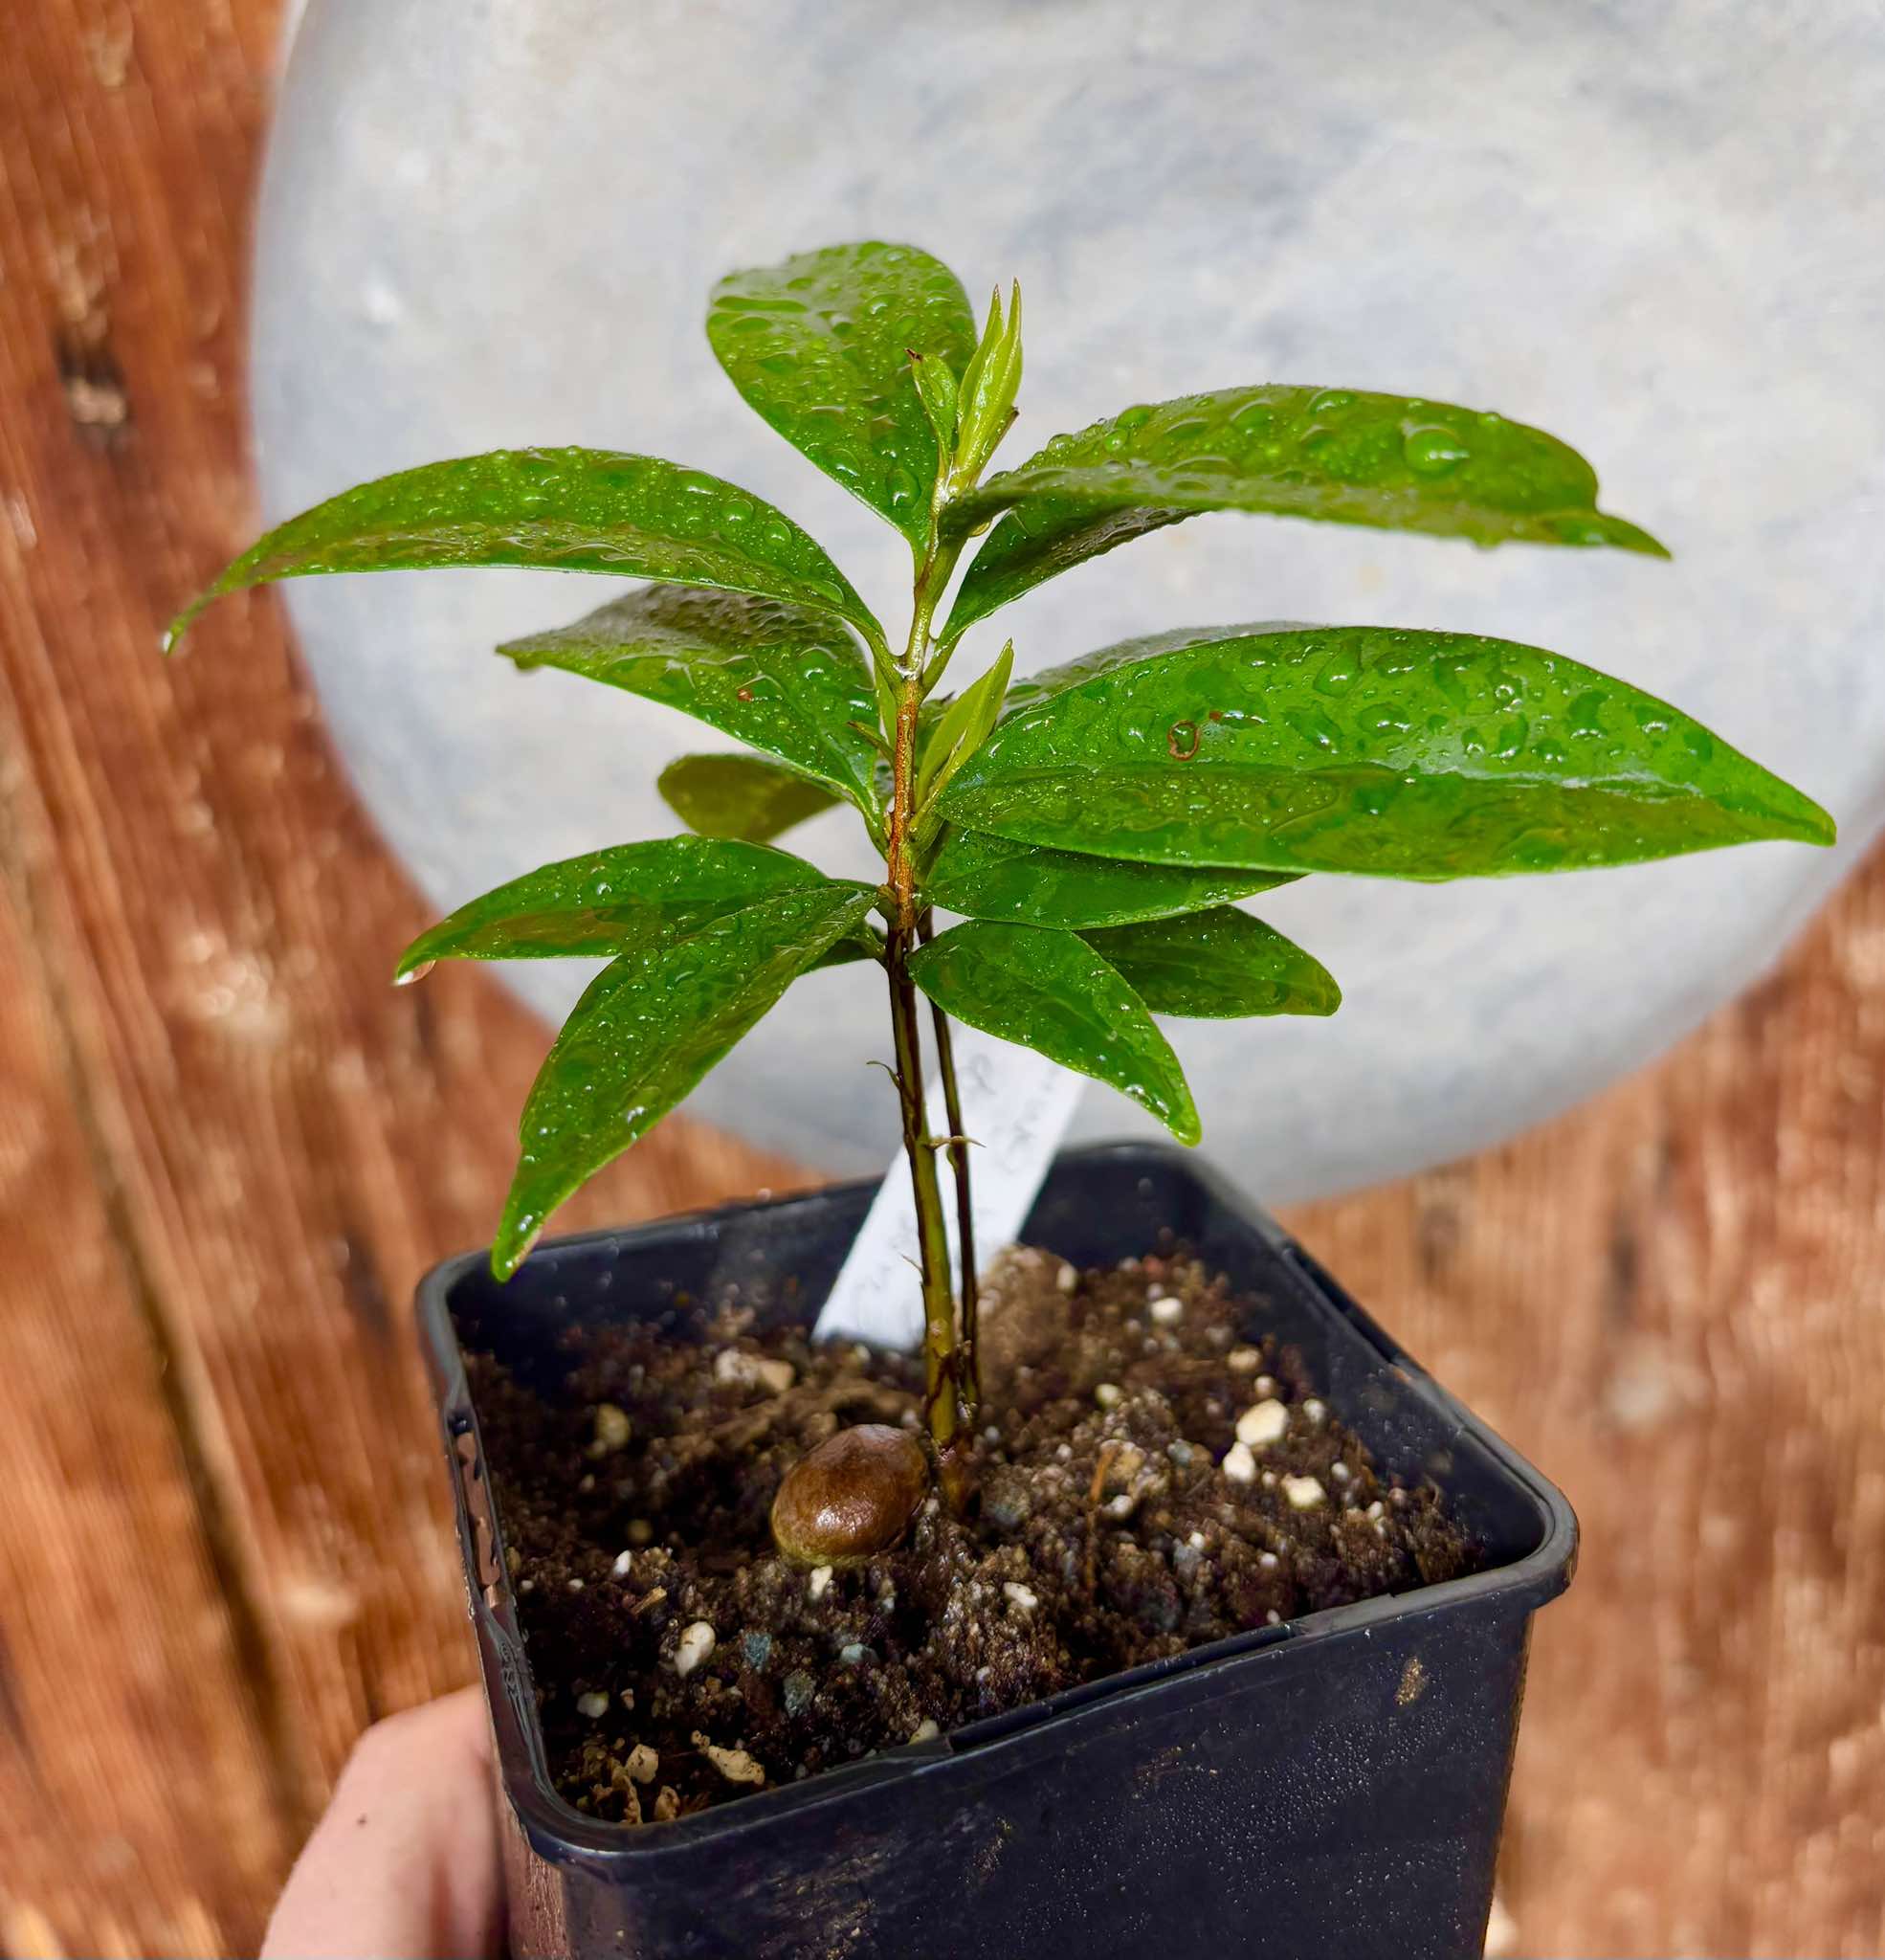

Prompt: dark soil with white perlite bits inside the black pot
xmin=466 ymin=1253 xmax=1474 ymax=1821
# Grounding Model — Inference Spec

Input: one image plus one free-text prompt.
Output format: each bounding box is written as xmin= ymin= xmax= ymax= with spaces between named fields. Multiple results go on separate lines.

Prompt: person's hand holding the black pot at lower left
xmin=260 ymin=1687 xmax=503 ymax=1960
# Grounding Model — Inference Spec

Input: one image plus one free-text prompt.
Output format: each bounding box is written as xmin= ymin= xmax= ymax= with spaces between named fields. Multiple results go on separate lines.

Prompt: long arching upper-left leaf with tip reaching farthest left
xmin=168 ymin=449 xmax=884 ymax=647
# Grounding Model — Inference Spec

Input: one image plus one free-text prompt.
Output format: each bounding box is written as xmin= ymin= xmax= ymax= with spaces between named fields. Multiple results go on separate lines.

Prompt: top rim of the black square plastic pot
xmin=417 ymin=1143 xmax=1577 ymax=1864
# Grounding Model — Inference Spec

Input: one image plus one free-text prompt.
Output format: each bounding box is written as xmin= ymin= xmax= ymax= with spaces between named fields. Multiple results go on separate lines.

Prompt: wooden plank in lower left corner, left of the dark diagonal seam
xmin=0 ymin=741 xmax=298 ymax=1956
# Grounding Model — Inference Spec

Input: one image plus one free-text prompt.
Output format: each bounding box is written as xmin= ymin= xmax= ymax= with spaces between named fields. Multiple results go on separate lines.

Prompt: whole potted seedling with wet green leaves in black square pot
xmin=172 ymin=243 xmax=1832 ymax=1956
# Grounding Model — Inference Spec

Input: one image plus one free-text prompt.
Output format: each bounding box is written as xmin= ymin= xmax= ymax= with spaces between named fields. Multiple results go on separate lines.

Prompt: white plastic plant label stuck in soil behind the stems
xmin=817 ymin=1021 xmax=1085 ymax=1348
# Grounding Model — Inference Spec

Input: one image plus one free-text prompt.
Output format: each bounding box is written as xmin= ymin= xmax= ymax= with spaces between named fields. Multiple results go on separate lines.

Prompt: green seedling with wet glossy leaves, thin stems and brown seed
xmin=172 ymin=243 xmax=1834 ymax=1536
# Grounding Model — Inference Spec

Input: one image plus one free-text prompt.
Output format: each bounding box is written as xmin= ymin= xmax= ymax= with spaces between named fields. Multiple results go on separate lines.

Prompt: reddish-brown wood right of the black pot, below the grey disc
xmin=1292 ymin=874 xmax=1885 ymax=1954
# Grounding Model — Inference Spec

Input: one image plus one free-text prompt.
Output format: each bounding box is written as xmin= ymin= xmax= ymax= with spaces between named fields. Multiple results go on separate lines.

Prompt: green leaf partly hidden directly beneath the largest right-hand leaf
xmin=923 ymin=831 xmax=1296 ymax=931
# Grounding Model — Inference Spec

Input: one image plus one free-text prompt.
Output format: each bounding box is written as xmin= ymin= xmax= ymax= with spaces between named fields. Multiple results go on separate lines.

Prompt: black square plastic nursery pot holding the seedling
xmin=419 ymin=1145 xmax=1577 ymax=1960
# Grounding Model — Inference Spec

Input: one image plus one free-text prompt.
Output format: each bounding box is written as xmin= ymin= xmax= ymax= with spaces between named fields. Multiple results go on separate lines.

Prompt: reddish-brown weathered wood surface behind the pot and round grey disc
xmin=0 ymin=0 xmax=1885 ymax=1956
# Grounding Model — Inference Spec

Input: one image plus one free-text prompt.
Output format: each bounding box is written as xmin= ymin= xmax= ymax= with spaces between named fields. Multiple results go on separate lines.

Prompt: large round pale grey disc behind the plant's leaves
xmin=253 ymin=0 xmax=1885 ymax=1203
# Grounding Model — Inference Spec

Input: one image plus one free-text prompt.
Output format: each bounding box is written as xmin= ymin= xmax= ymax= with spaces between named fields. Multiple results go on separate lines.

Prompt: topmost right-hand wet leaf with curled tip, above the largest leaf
xmin=942 ymin=389 xmax=1668 ymax=637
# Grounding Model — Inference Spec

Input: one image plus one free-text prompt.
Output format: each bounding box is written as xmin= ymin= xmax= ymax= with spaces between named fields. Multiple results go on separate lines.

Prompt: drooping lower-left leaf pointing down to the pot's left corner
xmin=492 ymin=880 xmax=876 ymax=1280
